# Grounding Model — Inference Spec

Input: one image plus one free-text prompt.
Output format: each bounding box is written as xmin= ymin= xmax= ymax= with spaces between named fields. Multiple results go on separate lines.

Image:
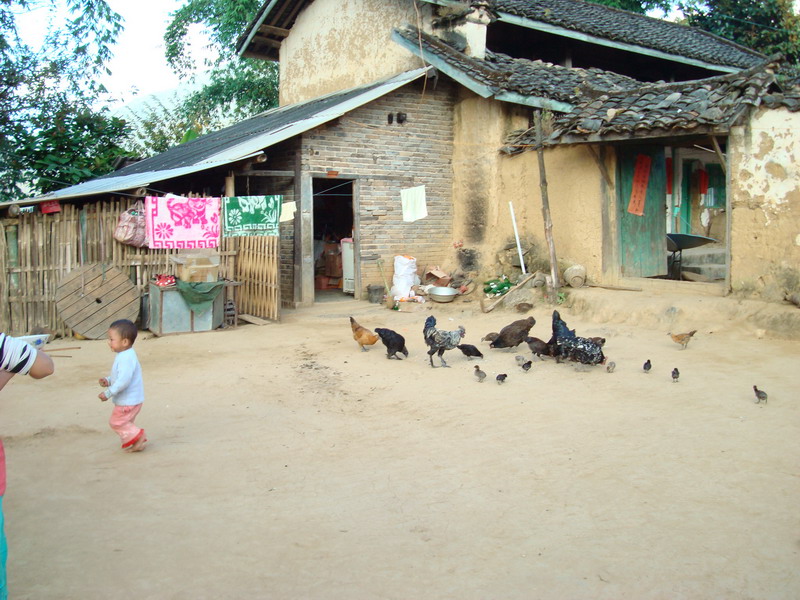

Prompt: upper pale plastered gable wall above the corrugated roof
xmin=280 ymin=0 xmax=431 ymax=106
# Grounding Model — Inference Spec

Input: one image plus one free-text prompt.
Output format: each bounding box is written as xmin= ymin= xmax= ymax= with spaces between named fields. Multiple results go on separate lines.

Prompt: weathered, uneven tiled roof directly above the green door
xmin=504 ymin=63 xmax=800 ymax=153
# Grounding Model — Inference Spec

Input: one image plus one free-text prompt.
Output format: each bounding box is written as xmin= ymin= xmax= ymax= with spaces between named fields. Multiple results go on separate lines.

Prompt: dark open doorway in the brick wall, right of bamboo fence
xmin=313 ymin=177 xmax=355 ymax=302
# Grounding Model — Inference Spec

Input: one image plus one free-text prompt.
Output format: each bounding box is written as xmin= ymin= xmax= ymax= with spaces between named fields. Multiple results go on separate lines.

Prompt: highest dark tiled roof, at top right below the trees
xmin=490 ymin=0 xmax=766 ymax=69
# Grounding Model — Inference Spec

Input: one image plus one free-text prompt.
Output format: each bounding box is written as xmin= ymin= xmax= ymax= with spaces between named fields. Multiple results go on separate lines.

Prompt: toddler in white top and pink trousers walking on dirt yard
xmin=98 ymin=319 xmax=147 ymax=452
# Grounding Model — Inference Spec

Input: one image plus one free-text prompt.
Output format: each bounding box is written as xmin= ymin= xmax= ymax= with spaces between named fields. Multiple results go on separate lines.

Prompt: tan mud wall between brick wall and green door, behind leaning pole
xmin=448 ymin=89 xmax=613 ymax=281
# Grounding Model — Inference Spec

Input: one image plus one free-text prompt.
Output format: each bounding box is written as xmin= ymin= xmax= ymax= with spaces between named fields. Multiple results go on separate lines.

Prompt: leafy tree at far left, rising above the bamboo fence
xmin=0 ymin=0 xmax=125 ymax=200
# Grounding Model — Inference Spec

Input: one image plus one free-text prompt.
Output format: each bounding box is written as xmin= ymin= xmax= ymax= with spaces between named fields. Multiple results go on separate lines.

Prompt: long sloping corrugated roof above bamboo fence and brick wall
xmin=26 ymin=67 xmax=431 ymax=204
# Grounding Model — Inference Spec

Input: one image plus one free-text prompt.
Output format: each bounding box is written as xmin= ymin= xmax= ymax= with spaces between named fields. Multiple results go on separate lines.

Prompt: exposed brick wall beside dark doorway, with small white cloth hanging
xmin=301 ymin=78 xmax=454 ymax=294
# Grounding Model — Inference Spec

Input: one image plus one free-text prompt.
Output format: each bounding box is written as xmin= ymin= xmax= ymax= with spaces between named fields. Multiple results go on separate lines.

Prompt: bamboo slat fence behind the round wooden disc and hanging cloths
xmin=0 ymin=198 xmax=278 ymax=336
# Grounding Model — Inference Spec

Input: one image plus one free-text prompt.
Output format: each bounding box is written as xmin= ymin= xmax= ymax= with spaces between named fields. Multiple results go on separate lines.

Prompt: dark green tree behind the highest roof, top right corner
xmin=681 ymin=0 xmax=800 ymax=65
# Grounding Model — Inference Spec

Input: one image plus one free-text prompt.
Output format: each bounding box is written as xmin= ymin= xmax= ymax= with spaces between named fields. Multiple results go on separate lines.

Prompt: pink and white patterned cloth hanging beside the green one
xmin=145 ymin=196 xmax=219 ymax=248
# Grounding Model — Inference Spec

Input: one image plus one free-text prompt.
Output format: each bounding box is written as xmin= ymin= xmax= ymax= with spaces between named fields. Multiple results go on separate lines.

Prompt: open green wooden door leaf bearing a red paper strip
xmin=617 ymin=146 xmax=667 ymax=277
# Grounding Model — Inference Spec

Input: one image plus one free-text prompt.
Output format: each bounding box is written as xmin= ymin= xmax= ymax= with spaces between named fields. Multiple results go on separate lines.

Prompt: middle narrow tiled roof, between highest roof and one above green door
xmin=395 ymin=27 xmax=642 ymax=105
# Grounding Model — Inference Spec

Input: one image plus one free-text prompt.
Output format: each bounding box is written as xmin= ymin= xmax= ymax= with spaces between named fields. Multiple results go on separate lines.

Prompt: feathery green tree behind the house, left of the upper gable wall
xmin=164 ymin=0 xmax=278 ymax=129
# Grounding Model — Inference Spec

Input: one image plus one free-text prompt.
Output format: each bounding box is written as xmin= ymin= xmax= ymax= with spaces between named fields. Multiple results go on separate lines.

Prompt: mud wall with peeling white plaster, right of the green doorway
xmin=729 ymin=109 xmax=800 ymax=299
